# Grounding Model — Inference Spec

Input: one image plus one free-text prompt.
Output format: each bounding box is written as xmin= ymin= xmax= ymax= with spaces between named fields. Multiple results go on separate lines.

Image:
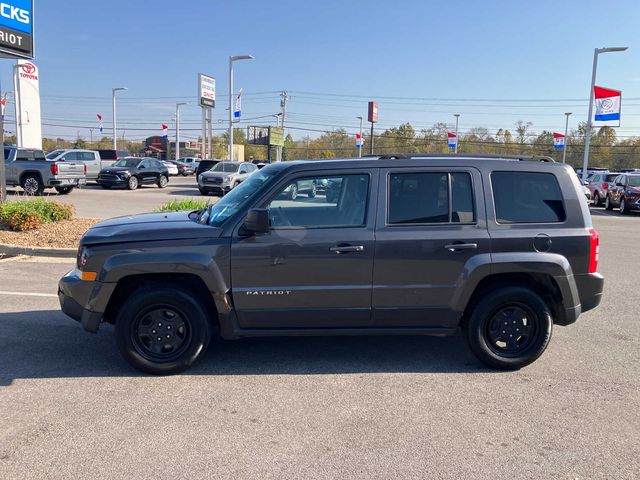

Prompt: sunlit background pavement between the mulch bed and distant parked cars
xmin=9 ymin=176 xmax=208 ymax=218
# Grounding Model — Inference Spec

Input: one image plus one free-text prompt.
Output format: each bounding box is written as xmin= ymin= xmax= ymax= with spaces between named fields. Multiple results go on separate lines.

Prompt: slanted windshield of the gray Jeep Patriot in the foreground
xmin=197 ymin=170 xmax=277 ymax=227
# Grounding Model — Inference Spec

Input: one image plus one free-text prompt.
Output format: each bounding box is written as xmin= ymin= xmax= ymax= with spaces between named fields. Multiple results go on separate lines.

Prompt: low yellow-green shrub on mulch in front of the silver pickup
xmin=0 ymin=198 xmax=73 ymax=231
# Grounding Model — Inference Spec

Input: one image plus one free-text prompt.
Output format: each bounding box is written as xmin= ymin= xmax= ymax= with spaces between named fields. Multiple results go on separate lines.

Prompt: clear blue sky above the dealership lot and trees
xmin=0 ymin=0 xmax=640 ymax=139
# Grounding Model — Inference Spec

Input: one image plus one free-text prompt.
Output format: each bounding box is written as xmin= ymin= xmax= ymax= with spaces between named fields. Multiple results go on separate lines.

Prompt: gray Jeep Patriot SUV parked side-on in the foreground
xmin=58 ymin=155 xmax=603 ymax=374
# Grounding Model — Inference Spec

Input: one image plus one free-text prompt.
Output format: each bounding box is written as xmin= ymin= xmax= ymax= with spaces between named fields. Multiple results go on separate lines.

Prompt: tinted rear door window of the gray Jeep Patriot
xmin=387 ymin=172 xmax=475 ymax=225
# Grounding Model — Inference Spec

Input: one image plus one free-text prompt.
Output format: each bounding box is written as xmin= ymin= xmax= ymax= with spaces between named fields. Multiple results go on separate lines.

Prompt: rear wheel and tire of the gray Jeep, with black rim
xmin=464 ymin=287 xmax=553 ymax=370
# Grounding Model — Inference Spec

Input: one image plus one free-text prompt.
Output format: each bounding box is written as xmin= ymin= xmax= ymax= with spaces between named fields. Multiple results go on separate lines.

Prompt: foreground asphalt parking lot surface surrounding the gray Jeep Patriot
xmin=0 ymin=211 xmax=640 ymax=479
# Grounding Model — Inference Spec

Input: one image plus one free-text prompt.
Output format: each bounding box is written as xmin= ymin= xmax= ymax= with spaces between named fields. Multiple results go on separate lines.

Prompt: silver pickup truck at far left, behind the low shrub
xmin=4 ymin=147 xmax=87 ymax=195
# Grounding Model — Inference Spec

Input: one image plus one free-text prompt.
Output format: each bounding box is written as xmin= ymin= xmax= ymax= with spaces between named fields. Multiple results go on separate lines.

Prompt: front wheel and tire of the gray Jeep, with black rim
xmin=115 ymin=284 xmax=211 ymax=375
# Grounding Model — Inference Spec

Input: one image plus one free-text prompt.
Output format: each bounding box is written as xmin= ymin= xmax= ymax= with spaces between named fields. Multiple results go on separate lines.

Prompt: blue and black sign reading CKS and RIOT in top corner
xmin=0 ymin=0 xmax=33 ymax=59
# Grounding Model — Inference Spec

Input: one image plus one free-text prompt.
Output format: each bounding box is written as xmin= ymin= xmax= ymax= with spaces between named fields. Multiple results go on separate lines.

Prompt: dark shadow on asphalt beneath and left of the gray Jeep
xmin=0 ymin=310 xmax=491 ymax=386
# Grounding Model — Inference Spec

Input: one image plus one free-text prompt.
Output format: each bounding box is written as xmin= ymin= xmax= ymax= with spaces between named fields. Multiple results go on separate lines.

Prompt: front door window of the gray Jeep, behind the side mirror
xmin=266 ymin=173 xmax=369 ymax=228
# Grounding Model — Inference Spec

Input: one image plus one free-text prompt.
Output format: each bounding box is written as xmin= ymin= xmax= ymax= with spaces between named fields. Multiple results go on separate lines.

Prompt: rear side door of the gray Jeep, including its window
xmin=372 ymin=167 xmax=490 ymax=327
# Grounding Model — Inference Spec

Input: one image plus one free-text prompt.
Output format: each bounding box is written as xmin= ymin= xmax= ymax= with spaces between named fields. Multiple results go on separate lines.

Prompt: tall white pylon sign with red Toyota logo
xmin=13 ymin=61 xmax=42 ymax=149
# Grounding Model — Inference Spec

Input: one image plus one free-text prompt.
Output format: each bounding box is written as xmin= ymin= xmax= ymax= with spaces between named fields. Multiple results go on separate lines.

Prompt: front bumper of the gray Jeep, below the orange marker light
xmin=58 ymin=269 xmax=116 ymax=333
